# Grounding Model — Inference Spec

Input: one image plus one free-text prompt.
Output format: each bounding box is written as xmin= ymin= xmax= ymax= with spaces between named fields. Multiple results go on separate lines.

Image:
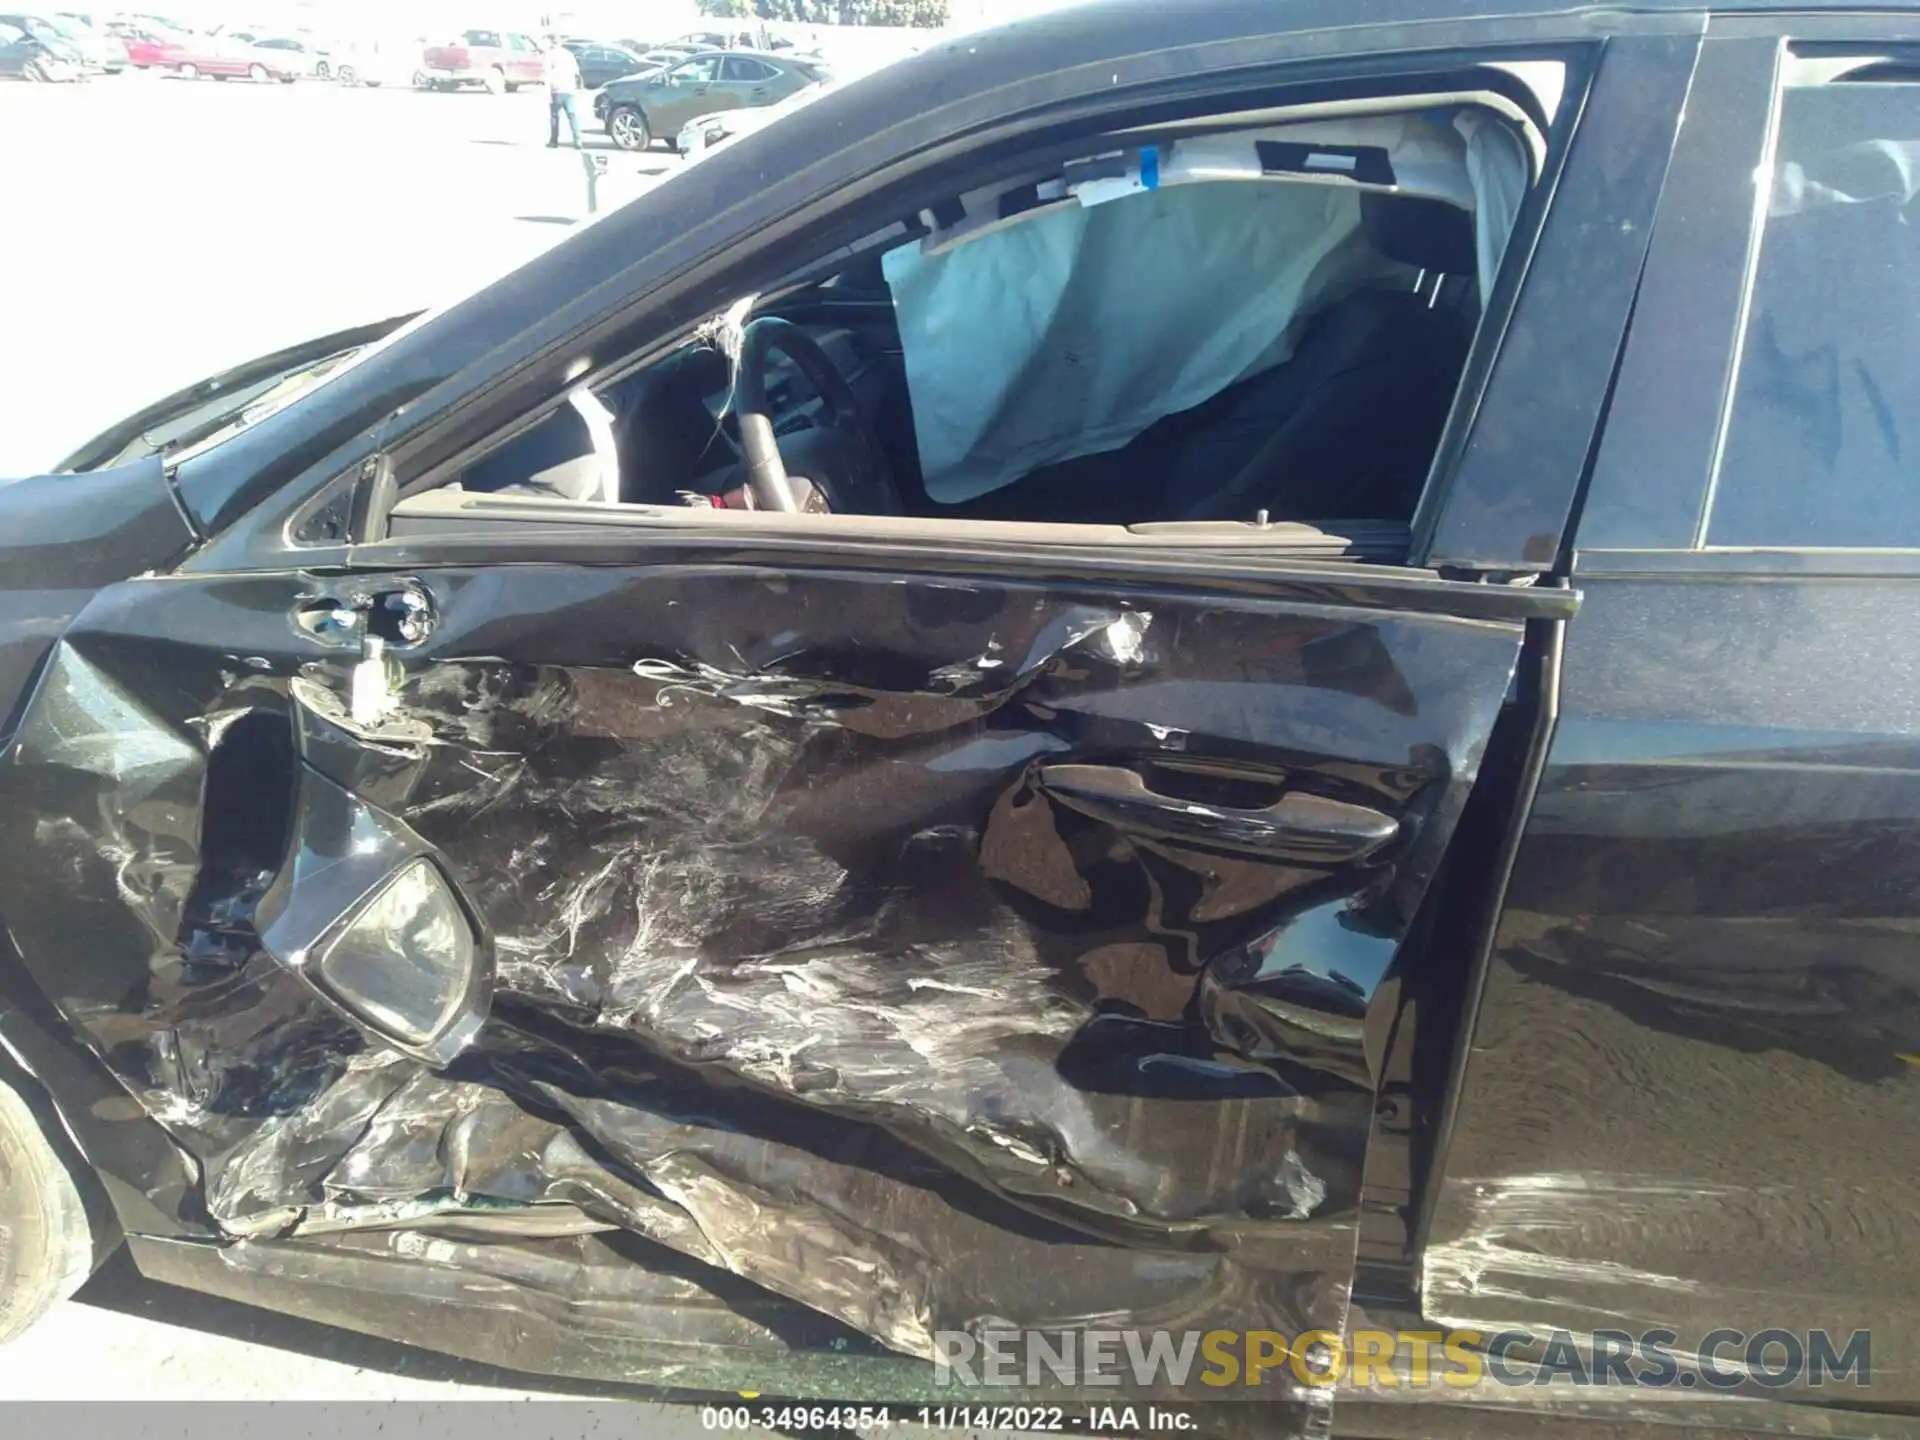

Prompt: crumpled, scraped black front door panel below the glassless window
xmin=0 ymin=564 xmax=1521 ymax=1384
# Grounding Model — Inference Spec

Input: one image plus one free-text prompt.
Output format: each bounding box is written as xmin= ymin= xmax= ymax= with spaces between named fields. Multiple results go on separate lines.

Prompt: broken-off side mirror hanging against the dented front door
xmin=255 ymin=764 xmax=493 ymax=1066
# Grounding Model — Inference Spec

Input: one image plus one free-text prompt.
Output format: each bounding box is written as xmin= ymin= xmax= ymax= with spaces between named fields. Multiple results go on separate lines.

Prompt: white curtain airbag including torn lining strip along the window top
xmin=883 ymin=111 xmax=1526 ymax=505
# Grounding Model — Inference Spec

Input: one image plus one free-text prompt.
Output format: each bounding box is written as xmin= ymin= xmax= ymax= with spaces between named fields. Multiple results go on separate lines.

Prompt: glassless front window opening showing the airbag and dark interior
xmin=399 ymin=102 xmax=1532 ymax=543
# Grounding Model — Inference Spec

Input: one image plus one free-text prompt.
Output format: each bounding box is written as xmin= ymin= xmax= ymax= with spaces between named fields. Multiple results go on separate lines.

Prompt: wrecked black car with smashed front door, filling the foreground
xmin=0 ymin=0 xmax=1920 ymax=1436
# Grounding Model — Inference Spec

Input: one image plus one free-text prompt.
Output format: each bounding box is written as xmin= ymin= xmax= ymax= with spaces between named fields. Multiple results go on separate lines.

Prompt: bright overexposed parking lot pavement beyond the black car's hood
xmin=0 ymin=75 xmax=678 ymax=476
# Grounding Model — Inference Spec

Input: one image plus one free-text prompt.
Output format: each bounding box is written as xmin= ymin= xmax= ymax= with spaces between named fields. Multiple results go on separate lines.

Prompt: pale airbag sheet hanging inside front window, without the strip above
xmin=885 ymin=184 xmax=1369 ymax=505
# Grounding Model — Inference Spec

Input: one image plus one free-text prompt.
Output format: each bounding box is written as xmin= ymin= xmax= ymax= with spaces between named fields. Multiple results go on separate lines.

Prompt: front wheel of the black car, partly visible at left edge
xmin=0 ymin=1077 xmax=94 ymax=1342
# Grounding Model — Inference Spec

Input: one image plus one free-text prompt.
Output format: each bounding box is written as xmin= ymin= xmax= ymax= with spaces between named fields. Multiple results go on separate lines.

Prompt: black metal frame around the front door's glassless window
xmin=182 ymin=15 xmax=1703 ymax=570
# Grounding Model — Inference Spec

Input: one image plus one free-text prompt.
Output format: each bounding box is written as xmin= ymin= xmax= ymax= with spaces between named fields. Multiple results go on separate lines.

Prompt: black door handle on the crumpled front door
xmin=1039 ymin=764 xmax=1400 ymax=864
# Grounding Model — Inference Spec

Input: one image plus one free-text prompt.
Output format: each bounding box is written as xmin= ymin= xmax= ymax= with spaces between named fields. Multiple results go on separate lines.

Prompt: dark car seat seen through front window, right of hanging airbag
xmin=1165 ymin=194 xmax=1478 ymax=520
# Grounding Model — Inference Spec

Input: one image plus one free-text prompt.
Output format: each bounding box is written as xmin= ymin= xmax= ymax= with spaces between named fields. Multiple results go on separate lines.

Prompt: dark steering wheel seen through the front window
xmin=733 ymin=315 xmax=900 ymax=515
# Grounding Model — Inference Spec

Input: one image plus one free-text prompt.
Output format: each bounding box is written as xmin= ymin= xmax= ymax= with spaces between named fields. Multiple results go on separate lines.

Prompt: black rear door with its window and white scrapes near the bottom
xmin=1427 ymin=15 xmax=1920 ymax=1407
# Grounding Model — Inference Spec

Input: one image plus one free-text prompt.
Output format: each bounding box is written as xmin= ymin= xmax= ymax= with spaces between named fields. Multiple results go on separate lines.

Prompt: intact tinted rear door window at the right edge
xmin=1707 ymin=83 xmax=1920 ymax=547
